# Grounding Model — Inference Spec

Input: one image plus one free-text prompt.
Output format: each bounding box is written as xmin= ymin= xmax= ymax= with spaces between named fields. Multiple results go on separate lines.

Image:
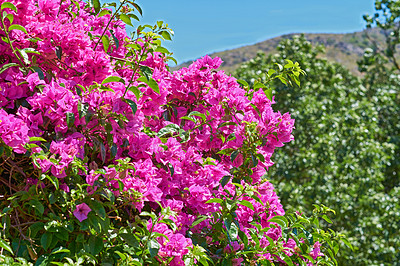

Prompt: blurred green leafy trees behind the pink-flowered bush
xmin=235 ymin=34 xmax=400 ymax=265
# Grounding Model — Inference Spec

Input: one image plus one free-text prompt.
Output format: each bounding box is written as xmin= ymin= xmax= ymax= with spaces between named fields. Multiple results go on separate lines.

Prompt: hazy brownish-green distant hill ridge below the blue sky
xmin=173 ymin=28 xmax=385 ymax=75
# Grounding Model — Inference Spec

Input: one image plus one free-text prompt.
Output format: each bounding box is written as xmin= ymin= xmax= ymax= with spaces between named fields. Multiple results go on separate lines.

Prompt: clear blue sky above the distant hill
xmin=122 ymin=0 xmax=374 ymax=64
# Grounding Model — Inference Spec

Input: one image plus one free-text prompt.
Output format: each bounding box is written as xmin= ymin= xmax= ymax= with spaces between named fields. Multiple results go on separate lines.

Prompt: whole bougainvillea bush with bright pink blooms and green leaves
xmin=0 ymin=0 xmax=346 ymax=265
